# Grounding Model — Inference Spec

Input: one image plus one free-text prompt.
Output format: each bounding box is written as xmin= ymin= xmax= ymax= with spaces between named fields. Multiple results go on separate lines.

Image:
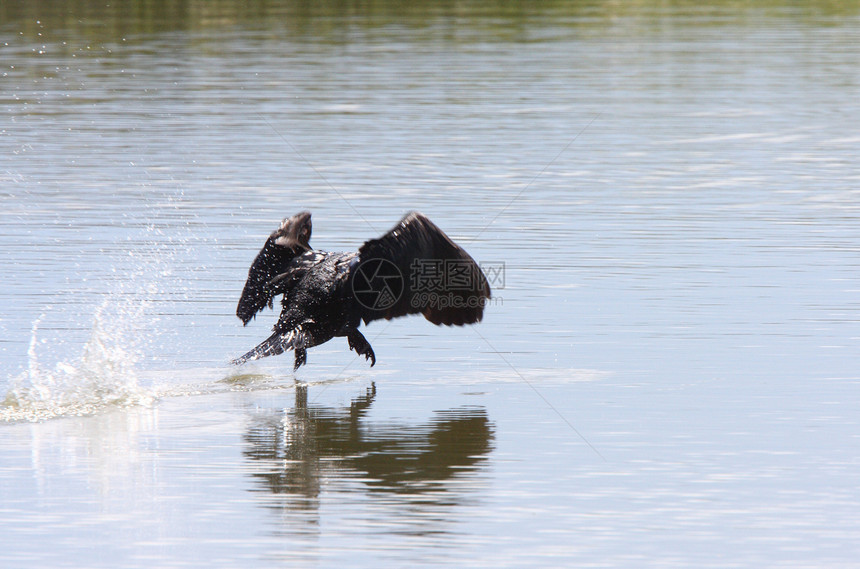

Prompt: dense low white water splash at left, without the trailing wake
xmin=0 ymin=299 xmax=155 ymax=422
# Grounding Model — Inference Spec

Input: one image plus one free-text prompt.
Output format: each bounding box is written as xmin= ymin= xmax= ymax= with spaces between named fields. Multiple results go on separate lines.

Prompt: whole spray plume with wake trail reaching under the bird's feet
xmin=0 ymin=215 xmax=370 ymax=424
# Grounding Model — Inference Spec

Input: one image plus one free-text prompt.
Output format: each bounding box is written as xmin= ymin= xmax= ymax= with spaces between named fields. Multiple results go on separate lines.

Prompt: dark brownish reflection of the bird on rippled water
xmin=245 ymin=384 xmax=493 ymax=520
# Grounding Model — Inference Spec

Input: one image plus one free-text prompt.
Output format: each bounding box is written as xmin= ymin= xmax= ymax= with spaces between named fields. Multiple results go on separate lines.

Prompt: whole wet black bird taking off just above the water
xmin=232 ymin=211 xmax=490 ymax=370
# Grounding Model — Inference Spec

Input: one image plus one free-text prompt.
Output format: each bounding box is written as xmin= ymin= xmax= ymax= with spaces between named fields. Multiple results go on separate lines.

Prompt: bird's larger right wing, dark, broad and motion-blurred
xmin=352 ymin=212 xmax=490 ymax=326
